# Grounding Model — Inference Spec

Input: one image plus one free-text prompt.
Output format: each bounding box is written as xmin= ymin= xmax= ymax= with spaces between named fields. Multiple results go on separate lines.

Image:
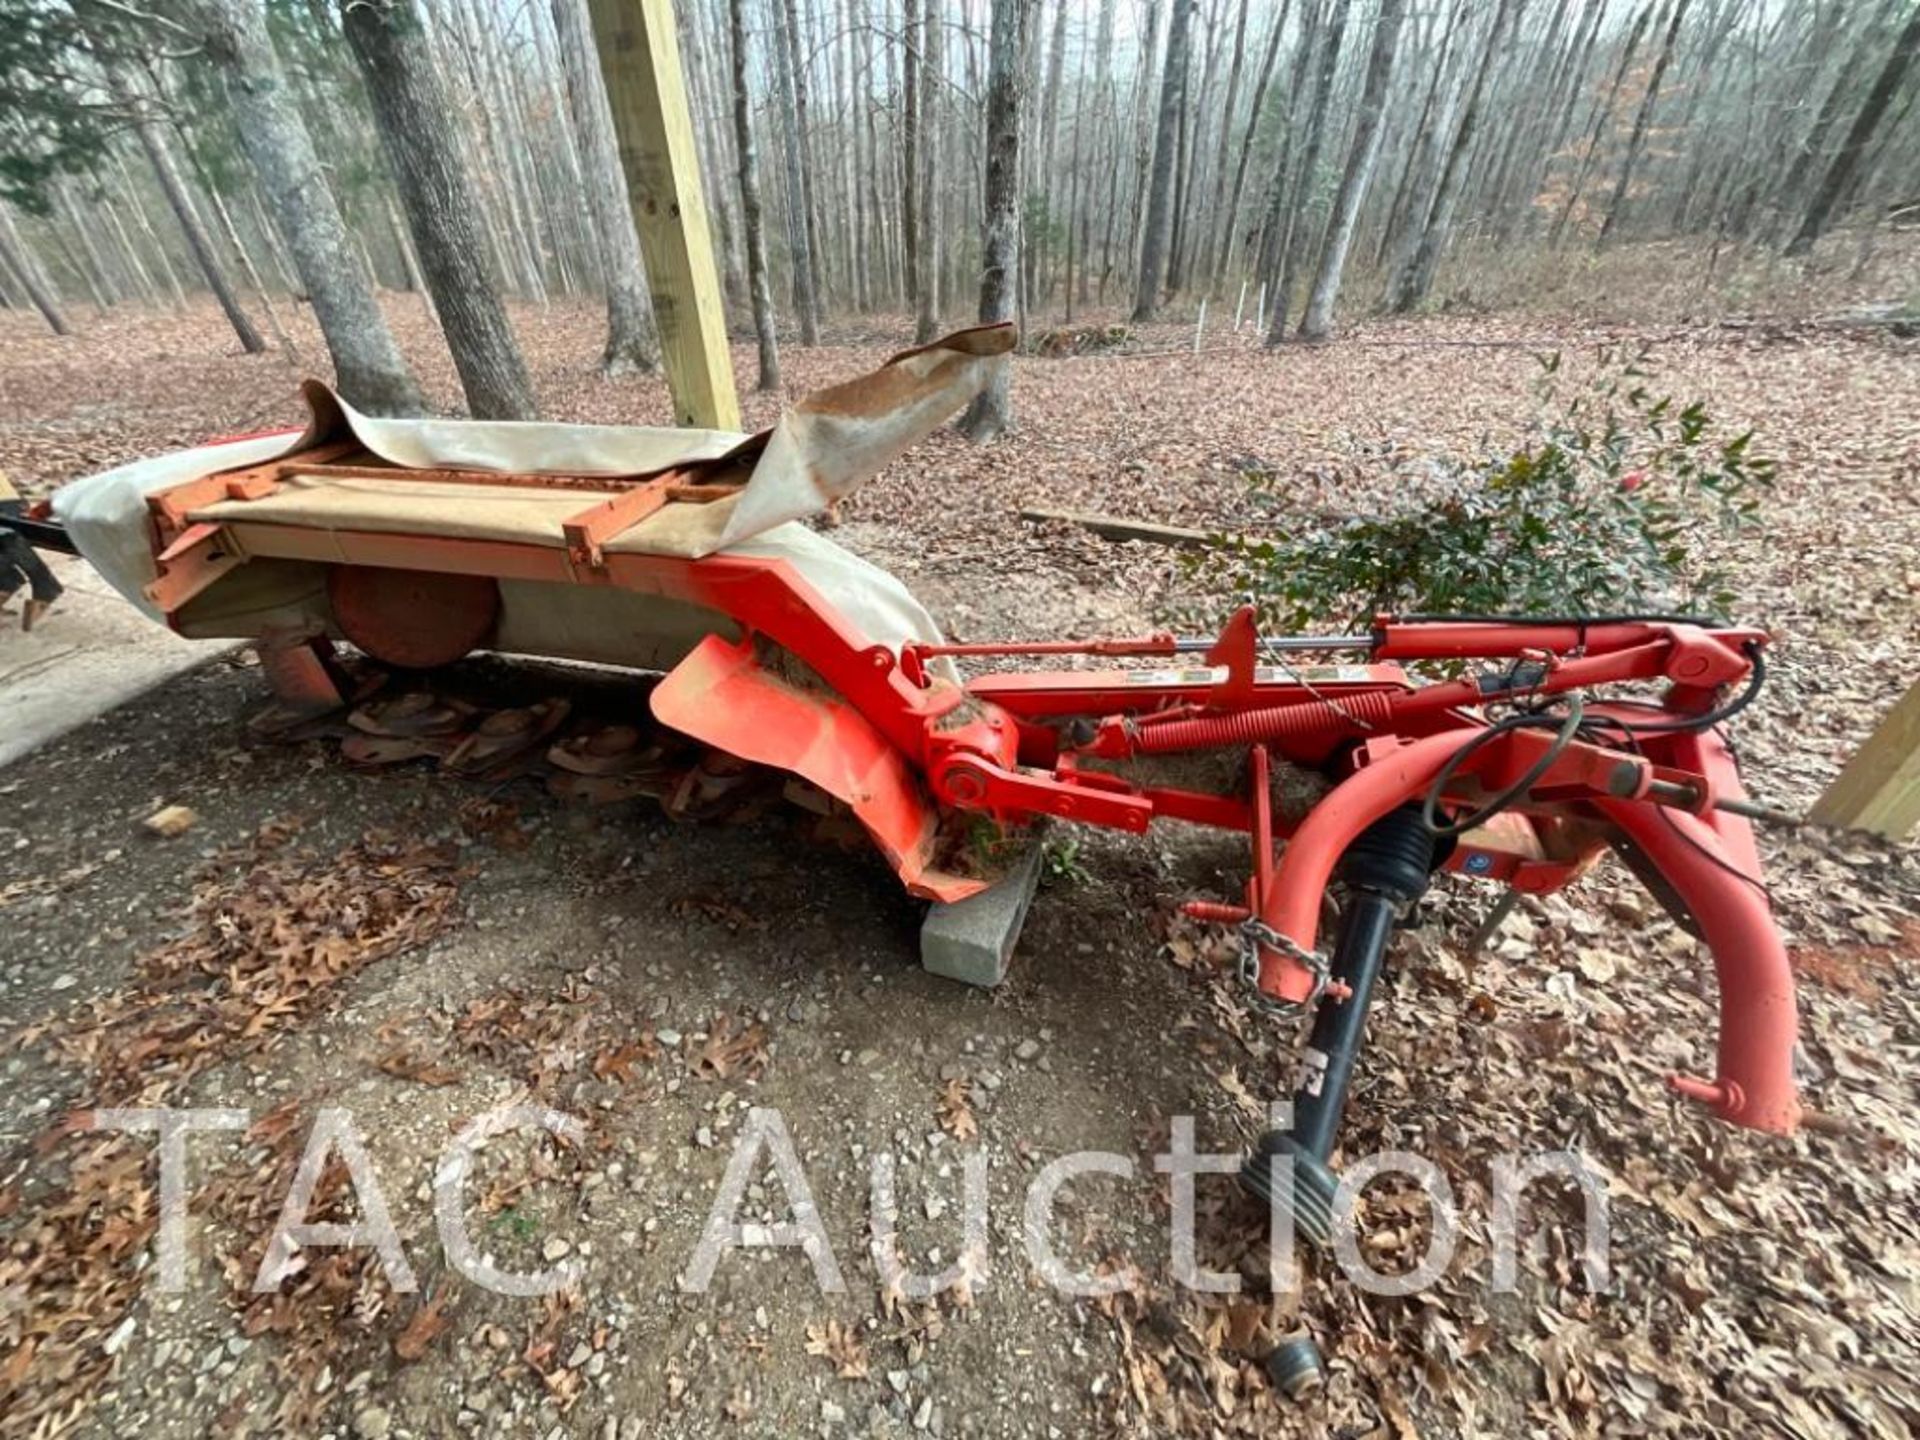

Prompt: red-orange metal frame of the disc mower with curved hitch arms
xmin=148 ymin=453 xmax=1799 ymax=1159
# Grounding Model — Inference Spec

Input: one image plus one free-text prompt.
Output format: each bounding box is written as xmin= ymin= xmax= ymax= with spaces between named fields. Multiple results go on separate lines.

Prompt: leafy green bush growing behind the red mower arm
xmin=1196 ymin=351 xmax=1774 ymax=634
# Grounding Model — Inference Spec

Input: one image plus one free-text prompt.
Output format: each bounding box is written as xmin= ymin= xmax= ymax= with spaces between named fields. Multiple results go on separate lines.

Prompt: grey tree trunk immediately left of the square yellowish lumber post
xmin=553 ymin=0 xmax=660 ymax=376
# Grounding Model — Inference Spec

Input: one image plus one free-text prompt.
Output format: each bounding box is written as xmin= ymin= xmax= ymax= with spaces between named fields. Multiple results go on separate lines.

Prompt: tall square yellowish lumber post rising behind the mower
xmin=588 ymin=0 xmax=739 ymax=430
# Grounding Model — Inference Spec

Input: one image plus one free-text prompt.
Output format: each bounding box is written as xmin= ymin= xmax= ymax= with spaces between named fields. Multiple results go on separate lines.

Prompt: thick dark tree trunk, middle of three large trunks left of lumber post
xmin=340 ymin=0 xmax=540 ymax=420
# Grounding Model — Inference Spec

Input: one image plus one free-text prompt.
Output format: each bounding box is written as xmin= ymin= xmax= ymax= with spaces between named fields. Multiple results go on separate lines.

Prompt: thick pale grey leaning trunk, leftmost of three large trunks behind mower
xmin=194 ymin=0 xmax=420 ymax=415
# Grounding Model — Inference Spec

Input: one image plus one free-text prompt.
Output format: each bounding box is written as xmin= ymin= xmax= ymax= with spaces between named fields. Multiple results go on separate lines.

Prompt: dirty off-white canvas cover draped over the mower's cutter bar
xmin=54 ymin=326 xmax=1012 ymax=664
